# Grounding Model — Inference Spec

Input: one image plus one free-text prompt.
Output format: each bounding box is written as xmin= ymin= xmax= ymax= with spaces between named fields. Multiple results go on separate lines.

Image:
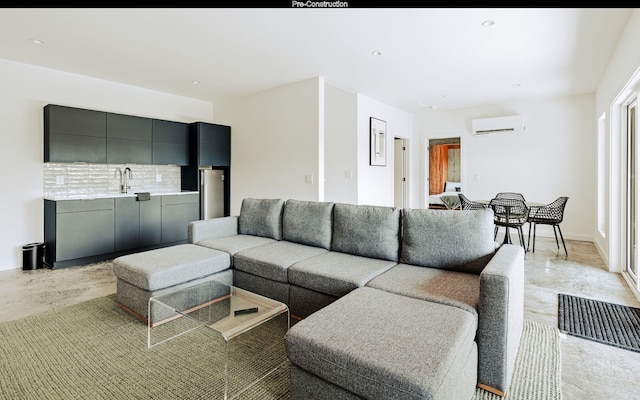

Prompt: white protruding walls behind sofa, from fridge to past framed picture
xmin=216 ymin=78 xmax=420 ymax=215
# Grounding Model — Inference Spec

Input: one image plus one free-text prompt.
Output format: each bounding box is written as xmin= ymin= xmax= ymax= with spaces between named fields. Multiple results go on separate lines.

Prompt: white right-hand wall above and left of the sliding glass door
xmin=593 ymin=9 xmax=640 ymax=272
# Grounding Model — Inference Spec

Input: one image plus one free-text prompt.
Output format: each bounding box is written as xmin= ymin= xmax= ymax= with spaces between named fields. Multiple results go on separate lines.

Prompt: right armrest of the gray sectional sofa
xmin=477 ymin=244 xmax=524 ymax=395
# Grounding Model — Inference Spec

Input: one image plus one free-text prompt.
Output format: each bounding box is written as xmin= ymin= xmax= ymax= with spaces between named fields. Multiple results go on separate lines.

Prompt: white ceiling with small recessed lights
xmin=0 ymin=8 xmax=632 ymax=112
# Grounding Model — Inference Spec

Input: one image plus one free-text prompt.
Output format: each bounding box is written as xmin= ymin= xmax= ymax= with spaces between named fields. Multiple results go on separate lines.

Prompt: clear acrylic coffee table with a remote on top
xmin=147 ymin=280 xmax=291 ymax=399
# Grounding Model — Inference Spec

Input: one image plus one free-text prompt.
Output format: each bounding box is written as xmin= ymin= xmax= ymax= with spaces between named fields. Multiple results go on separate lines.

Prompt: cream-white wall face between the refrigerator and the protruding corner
xmin=216 ymin=78 xmax=324 ymax=215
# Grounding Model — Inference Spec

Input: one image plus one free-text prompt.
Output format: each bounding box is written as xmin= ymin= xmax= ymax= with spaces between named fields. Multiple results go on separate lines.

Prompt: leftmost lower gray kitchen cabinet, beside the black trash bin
xmin=45 ymin=198 xmax=115 ymax=268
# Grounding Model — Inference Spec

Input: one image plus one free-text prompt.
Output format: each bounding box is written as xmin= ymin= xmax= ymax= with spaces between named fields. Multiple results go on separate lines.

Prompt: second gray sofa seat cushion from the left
xmin=233 ymin=240 xmax=328 ymax=283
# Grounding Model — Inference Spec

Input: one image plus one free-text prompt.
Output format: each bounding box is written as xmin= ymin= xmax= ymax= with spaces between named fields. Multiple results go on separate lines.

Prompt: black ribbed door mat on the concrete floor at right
xmin=558 ymin=293 xmax=640 ymax=352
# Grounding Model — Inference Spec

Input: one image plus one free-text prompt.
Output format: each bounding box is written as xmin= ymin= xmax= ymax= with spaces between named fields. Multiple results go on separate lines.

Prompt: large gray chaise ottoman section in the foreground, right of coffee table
xmin=285 ymin=287 xmax=478 ymax=400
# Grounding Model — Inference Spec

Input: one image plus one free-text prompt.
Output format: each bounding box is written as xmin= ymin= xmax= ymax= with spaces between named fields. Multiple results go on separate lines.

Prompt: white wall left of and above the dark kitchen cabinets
xmin=0 ymin=59 xmax=212 ymax=270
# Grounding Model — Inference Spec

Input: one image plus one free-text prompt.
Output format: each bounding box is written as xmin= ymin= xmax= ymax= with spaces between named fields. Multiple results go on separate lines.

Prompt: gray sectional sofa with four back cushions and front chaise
xmin=188 ymin=199 xmax=524 ymax=399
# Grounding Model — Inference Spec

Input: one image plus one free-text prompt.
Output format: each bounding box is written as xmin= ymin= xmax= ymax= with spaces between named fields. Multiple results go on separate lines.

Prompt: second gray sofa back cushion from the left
xmin=282 ymin=200 xmax=333 ymax=250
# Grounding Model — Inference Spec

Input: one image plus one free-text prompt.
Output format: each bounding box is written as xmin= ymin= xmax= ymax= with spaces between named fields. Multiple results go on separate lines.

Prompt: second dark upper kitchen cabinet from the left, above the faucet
xmin=107 ymin=113 xmax=153 ymax=164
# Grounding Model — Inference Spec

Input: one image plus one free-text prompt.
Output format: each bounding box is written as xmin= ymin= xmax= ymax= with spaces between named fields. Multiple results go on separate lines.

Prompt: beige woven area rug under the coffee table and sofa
xmin=0 ymin=295 xmax=561 ymax=400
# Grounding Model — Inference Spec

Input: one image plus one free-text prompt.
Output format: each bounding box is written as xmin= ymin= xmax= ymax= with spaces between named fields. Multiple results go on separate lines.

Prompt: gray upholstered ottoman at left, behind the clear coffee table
xmin=113 ymin=244 xmax=233 ymax=323
